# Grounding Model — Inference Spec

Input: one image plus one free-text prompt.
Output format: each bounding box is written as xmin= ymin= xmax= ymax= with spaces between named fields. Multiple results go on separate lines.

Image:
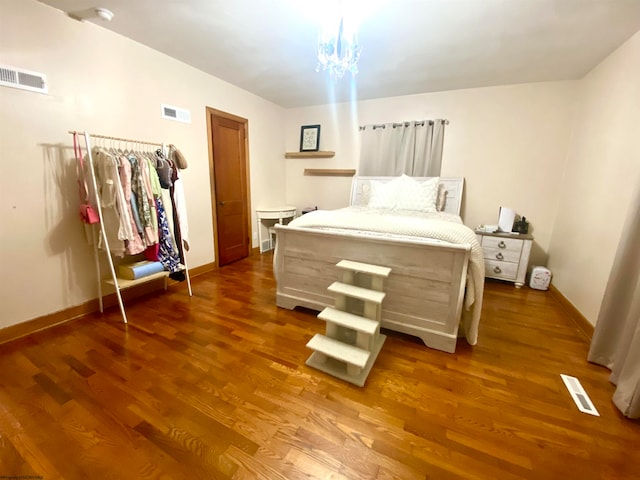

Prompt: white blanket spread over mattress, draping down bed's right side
xmin=289 ymin=207 xmax=484 ymax=345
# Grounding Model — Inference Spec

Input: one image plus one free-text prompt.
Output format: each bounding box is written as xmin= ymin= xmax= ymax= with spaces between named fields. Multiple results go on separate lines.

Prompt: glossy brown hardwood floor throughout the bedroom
xmin=0 ymin=254 xmax=640 ymax=480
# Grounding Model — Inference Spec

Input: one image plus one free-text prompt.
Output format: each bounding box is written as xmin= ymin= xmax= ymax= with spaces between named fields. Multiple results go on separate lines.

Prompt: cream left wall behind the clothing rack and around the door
xmin=0 ymin=0 xmax=285 ymax=328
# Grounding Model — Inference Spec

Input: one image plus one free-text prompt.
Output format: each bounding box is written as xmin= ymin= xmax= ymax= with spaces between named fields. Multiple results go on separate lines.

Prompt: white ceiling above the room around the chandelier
xmin=40 ymin=0 xmax=640 ymax=108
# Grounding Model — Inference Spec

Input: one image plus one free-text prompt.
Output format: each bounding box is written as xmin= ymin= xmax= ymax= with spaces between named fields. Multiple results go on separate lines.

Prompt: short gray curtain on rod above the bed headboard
xmin=358 ymin=119 xmax=447 ymax=177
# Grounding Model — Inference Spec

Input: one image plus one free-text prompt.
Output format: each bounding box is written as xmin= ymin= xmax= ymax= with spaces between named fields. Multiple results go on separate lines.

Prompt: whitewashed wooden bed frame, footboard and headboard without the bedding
xmin=274 ymin=177 xmax=471 ymax=353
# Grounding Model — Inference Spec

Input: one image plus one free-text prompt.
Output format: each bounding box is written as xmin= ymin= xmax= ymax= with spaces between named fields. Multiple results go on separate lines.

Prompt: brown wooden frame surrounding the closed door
xmin=205 ymin=107 xmax=254 ymax=268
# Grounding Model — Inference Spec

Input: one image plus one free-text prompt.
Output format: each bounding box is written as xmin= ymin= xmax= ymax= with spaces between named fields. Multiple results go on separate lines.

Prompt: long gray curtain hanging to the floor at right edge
xmin=588 ymin=177 xmax=640 ymax=418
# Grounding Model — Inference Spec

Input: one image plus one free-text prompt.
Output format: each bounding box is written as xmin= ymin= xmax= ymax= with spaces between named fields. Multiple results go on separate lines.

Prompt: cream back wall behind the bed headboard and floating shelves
xmin=285 ymin=77 xmax=577 ymax=264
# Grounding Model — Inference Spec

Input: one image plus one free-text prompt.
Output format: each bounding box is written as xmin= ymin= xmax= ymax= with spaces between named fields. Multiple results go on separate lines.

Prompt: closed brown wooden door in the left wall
xmin=207 ymin=108 xmax=251 ymax=266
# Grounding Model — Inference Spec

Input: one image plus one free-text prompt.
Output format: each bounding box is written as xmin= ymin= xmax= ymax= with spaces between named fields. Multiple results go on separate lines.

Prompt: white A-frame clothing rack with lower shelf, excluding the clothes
xmin=68 ymin=130 xmax=193 ymax=323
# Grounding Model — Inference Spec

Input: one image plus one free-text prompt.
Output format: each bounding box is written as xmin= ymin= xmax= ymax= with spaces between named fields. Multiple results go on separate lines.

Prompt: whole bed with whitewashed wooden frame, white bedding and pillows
xmin=274 ymin=176 xmax=484 ymax=353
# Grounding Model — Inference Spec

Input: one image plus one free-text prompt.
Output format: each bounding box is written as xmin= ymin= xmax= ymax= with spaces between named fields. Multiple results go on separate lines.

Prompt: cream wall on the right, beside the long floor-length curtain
xmin=549 ymin=32 xmax=640 ymax=324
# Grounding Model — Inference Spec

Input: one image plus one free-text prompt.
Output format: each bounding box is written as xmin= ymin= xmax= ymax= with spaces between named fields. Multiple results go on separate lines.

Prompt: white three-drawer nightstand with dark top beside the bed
xmin=476 ymin=230 xmax=533 ymax=288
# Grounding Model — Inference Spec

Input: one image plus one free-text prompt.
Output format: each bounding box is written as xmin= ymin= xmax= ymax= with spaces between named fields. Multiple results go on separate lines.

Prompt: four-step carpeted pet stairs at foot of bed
xmin=306 ymin=260 xmax=391 ymax=387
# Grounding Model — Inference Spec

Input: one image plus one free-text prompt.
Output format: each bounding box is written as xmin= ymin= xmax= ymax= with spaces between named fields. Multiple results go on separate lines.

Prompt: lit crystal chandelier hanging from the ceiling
xmin=316 ymin=14 xmax=360 ymax=79
